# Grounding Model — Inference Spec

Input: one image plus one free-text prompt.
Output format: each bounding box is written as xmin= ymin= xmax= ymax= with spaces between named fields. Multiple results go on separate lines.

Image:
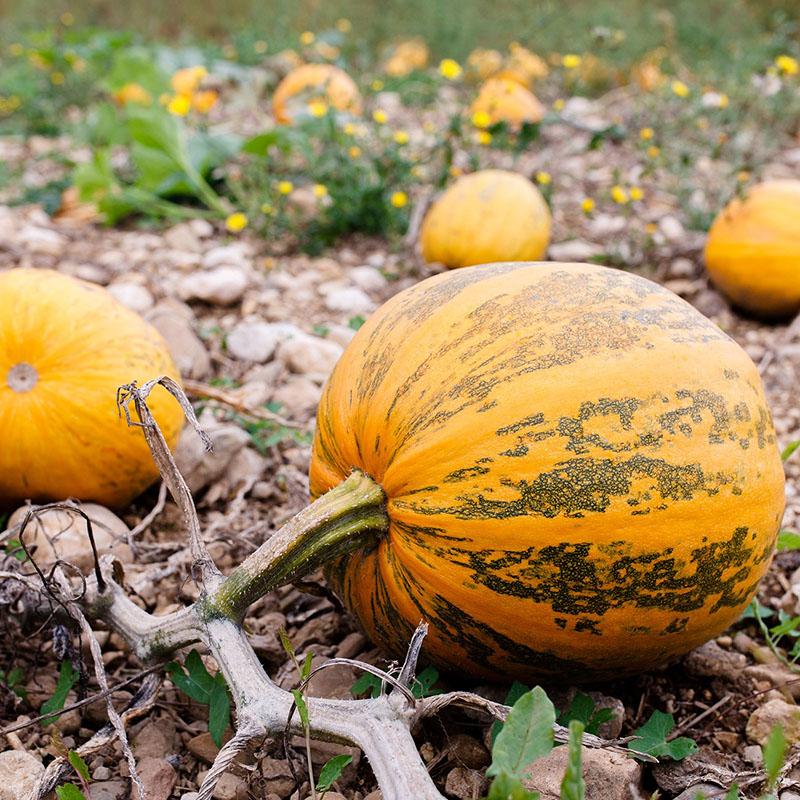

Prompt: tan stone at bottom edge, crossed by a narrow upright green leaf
xmin=523 ymin=746 xmax=642 ymax=800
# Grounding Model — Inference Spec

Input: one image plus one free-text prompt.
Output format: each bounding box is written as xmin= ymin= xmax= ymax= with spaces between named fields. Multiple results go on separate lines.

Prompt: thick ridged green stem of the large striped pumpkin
xmin=199 ymin=470 xmax=389 ymax=620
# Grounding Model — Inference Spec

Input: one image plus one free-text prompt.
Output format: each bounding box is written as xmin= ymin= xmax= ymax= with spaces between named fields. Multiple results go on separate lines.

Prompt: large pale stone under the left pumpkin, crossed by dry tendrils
xmin=8 ymin=503 xmax=133 ymax=572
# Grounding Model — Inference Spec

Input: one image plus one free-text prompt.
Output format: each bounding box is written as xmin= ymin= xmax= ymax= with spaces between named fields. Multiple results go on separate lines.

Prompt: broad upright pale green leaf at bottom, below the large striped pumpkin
xmin=486 ymin=686 xmax=556 ymax=778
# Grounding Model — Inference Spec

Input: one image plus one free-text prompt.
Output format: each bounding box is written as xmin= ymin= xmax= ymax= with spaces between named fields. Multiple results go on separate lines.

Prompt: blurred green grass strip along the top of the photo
xmin=0 ymin=0 xmax=800 ymax=80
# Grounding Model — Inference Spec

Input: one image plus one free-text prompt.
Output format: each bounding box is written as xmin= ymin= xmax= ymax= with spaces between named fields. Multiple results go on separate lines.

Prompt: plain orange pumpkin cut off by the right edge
xmin=705 ymin=180 xmax=800 ymax=317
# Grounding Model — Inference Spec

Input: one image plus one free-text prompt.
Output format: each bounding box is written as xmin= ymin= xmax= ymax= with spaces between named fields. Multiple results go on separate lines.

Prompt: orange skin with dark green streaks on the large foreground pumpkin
xmin=310 ymin=263 xmax=784 ymax=680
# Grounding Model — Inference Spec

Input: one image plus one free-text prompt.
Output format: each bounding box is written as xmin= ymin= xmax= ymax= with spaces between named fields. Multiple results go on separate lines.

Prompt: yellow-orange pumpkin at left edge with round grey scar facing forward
xmin=0 ymin=269 xmax=183 ymax=507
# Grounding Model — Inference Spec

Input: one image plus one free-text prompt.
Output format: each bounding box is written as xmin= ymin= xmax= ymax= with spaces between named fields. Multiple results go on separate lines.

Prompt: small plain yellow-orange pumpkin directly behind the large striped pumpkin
xmin=420 ymin=169 xmax=550 ymax=267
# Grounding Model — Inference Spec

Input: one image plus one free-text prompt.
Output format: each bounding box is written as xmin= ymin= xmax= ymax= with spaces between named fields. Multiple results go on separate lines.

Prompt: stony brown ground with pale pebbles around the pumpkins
xmin=0 ymin=108 xmax=800 ymax=800
